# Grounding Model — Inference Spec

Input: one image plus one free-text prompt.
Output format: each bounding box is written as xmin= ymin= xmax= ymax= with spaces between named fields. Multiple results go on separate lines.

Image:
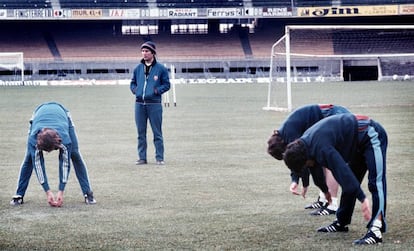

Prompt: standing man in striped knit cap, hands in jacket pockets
xmin=130 ymin=41 xmax=170 ymax=165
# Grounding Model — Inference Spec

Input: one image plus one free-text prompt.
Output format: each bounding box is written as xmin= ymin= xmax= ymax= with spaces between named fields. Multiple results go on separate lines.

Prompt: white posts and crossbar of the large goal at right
xmin=263 ymin=25 xmax=414 ymax=112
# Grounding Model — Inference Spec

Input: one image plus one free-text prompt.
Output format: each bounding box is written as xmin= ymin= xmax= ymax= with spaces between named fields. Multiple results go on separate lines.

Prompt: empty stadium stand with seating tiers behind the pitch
xmin=0 ymin=0 xmax=414 ymax=80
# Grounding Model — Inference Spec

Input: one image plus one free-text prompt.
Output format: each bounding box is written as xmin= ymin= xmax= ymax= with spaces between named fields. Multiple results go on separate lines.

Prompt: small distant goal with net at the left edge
xmin=0 ymin=52 xmax=24 ymax=83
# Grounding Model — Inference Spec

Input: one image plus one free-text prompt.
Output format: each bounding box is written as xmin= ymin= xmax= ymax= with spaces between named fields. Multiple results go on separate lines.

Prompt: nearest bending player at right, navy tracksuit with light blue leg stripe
xmin=284 ymin=114 xmax=388 ymax=244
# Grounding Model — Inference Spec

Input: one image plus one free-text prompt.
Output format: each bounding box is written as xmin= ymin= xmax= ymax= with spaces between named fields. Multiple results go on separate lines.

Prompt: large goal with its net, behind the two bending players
xmin=263 ymin=25 xmax=414 ymax=111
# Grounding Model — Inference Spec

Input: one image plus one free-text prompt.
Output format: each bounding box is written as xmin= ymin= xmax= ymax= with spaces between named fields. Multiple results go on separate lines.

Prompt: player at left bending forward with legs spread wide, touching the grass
xmin=10 ymin=102 xmax=96 ymax=206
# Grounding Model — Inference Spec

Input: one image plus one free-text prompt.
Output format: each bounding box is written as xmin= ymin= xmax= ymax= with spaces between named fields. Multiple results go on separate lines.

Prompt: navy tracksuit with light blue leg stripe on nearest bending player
xmin=300 ymin=113 xmax=388 ymax=232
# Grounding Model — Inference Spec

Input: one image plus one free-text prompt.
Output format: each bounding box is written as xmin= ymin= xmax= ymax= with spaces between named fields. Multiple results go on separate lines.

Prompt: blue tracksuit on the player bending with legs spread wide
xmin=16 ymin=102 xmax=91 ymax=196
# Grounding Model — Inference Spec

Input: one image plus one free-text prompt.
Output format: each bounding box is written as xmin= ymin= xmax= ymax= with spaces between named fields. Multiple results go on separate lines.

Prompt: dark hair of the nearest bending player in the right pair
xmin=283 ymin=139 xmax=308 ymax=177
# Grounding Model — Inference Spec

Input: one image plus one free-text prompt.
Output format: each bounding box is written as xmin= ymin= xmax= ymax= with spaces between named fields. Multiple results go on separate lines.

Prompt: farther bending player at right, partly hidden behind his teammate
xmin=268 ymin=104 xmax=349 ymax=215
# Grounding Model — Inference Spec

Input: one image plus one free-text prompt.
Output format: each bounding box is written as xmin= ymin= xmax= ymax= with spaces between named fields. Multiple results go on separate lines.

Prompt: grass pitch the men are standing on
xmin=0 ymin=82 xmax=414 ymax=250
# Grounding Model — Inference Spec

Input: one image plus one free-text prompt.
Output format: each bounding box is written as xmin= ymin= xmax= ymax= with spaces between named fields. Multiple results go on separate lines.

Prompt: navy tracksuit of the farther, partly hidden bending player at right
xmin=278 ymin=104 xmax=349 ymax=187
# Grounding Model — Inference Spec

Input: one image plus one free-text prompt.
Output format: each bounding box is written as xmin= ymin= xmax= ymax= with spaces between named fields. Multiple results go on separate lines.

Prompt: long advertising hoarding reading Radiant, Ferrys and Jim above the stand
xmin=0 ymin=4 xmax=414 ymax=20
